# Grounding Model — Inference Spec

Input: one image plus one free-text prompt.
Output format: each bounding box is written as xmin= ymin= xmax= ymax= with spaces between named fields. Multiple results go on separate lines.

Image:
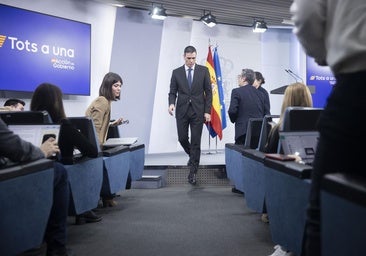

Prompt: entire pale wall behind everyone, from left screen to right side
xmin=0 ymin=0 xmax=303 ymax=153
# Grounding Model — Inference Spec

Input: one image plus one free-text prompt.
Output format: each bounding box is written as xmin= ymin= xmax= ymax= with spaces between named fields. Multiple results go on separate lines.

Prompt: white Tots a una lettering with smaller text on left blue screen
xmin=0 ymin=35 xmax=75 ymax=70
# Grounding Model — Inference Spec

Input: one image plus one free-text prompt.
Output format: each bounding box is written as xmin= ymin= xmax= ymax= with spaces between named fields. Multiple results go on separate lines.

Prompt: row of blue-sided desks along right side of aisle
xmin=225 ymin=144 xmax=366 ymax=256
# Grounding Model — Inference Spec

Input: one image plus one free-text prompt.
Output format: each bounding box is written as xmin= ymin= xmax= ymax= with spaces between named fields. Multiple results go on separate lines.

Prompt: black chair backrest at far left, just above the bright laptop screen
xmin=0 ymin=110 xmax=52 ymax=125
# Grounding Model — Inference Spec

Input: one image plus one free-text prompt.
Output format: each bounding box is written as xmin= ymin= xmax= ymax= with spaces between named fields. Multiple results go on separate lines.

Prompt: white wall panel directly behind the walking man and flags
xmin=148 ymin=17 xmax=292 ymax=153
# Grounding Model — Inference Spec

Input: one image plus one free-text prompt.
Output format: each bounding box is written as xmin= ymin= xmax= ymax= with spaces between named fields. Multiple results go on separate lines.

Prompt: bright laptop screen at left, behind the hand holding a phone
xmin=8 ymin=124 xmax=60 ymax=147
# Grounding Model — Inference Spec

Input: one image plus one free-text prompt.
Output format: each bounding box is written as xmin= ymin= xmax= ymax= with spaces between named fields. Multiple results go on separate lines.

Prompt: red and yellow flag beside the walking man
xmin=206 ymin=46 xmax=222 ymax=140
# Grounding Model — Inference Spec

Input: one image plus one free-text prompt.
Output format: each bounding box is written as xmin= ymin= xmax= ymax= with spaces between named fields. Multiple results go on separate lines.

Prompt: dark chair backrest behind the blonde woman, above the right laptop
xmin=280 ymin=107 xmax=323 ymax=132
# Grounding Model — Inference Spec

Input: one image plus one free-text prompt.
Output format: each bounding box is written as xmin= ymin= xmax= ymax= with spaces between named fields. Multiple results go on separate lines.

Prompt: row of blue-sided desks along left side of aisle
xmin=0 ymin=144 xmax=145 ymax=255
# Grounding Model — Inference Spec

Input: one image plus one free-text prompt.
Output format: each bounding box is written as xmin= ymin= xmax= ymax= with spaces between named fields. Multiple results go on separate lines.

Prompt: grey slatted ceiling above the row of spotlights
xmin=99 ymin=0 xmax=292 ymax=27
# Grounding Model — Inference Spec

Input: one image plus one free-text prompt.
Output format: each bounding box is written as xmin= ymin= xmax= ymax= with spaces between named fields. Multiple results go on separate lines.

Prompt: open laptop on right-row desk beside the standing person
xmin=279 ymin=131 xmax=319 ymax=165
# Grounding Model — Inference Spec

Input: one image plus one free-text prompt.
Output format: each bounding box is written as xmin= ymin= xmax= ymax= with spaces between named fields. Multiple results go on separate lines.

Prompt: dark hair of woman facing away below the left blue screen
xmin=30 ymin=83 xmax=66 ymax=123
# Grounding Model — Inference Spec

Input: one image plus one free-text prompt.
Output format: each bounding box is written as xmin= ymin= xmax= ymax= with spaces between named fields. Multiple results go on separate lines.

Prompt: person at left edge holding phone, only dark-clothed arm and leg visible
xmin=0 ymin=119 xmax=72 ymax=256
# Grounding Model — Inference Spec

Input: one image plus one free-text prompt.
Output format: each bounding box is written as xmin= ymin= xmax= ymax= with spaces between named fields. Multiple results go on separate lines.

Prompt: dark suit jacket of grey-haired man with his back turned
xmin=228 ymin=84 xmax=265 ymax=139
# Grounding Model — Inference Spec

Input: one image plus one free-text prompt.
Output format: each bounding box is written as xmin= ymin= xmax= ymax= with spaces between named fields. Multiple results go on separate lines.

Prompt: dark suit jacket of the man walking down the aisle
xmin=169 ymin=64 xmax=212 ymax=120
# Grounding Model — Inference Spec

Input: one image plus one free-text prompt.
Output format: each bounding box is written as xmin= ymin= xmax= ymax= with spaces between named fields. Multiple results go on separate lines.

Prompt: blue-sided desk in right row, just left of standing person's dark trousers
xmin=264 ymin=158 xmax=312 ymax=255
